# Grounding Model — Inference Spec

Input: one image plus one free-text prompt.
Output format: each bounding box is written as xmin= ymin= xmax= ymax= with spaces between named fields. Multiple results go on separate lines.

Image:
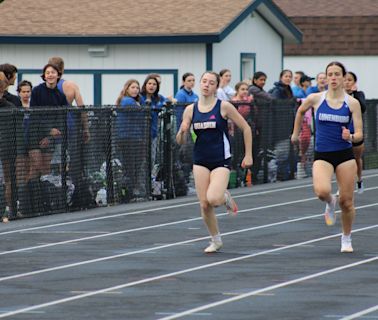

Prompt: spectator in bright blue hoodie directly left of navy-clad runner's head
xmin=175 ymin=72 xmax=198 ymax=132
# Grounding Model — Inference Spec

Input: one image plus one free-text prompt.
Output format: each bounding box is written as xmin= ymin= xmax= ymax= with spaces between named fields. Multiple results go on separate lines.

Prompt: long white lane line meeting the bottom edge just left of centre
xmin=158 ymin=257 xmax=378 ymax=320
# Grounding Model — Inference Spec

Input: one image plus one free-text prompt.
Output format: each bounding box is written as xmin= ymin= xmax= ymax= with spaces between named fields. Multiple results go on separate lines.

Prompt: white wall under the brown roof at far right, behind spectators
xmin=284 ymin=56 xmax=378 ymax=99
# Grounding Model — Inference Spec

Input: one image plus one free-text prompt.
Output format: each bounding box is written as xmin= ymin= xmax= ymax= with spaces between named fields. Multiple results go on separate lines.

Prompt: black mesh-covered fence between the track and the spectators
xmin=0 ymin=100 xmax=378 ymax=218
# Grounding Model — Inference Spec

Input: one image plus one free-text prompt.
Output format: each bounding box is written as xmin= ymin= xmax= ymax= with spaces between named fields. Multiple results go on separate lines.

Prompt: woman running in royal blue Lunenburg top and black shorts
xmin=291 ymin=61 xmax=363 ymax=252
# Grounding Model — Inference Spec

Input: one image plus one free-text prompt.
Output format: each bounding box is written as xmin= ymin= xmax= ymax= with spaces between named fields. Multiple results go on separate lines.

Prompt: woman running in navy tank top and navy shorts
xmin=176 ymin=72 xmax=252 ymax=253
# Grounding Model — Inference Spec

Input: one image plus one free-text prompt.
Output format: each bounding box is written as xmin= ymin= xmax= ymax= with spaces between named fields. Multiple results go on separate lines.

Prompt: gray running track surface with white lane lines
xmin=0 ymin=170 xmax=378 ymax=320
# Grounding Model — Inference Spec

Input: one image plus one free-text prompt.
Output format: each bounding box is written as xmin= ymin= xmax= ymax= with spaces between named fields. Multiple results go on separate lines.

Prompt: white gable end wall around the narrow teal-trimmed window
xmin=213 ymin=13 xmax=282 ymax=90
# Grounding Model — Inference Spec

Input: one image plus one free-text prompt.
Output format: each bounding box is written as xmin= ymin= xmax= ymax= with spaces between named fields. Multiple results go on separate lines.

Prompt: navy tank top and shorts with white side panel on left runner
xmin=192 ymin=99 xmax=231 ymax=171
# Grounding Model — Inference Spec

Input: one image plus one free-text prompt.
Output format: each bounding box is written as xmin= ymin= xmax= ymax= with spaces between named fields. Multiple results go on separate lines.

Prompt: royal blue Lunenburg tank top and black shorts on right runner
xmin=314 ymin=91 xmax=354 ymax=169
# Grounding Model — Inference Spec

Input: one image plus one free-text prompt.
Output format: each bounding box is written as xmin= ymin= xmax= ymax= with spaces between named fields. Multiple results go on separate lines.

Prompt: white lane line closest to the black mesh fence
xmin=0 ymin=174 xmax=378 ymax=236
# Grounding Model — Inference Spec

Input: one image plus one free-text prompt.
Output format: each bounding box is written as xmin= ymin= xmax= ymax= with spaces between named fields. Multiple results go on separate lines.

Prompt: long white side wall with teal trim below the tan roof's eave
xmin=0 ymin=44 xmax=206 ymax=104
